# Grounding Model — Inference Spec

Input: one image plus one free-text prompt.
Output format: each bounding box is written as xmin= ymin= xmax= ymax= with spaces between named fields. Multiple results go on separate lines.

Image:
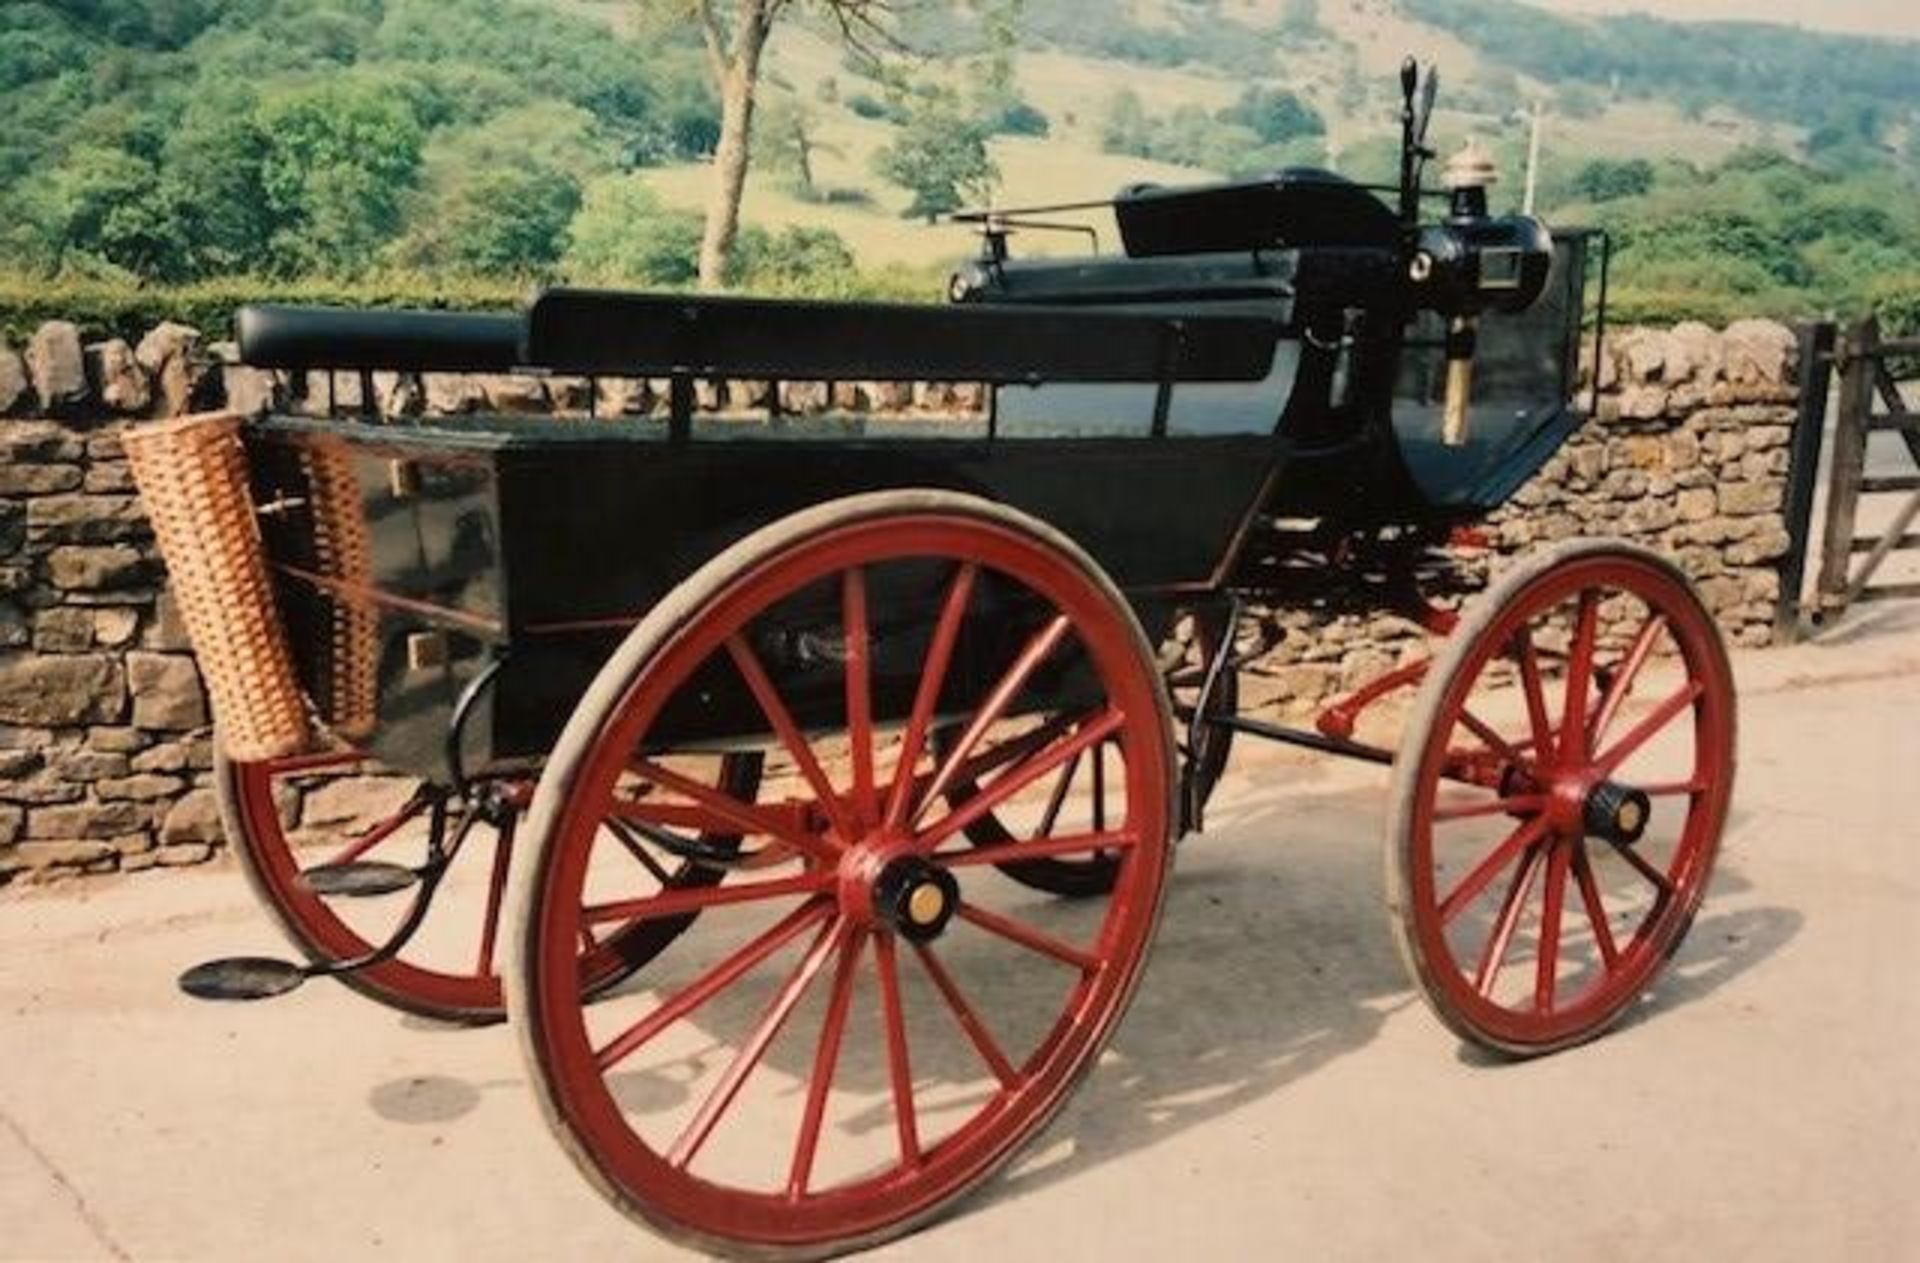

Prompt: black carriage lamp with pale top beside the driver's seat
xmin=1407 ymin=140 xmax=1553 ymax=447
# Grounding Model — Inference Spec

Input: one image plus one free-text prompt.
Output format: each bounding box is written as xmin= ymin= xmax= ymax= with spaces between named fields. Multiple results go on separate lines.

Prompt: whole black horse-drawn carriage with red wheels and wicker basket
xmin=129 ymin=66 xmax=1734 ymax=1253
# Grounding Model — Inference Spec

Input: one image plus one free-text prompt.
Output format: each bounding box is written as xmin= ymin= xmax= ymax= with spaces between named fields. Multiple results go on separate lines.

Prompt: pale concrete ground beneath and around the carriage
xmin=0 ymin=605 xmax=1920 ymax=1263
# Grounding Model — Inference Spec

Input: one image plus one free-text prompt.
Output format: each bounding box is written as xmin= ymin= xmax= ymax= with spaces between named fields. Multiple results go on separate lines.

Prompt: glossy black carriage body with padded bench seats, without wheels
xmin=242 ymin=169 xmax=1584 ymax=775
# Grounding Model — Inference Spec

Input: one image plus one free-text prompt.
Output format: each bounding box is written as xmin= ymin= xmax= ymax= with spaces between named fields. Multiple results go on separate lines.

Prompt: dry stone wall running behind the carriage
xmin=0 ymin=321 xmax=1797 ymax=885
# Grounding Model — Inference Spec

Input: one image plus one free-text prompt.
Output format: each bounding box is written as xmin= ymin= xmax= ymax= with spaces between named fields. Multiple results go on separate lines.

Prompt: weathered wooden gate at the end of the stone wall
xmin=1776 ymin=309 xmax=1920 ymax=639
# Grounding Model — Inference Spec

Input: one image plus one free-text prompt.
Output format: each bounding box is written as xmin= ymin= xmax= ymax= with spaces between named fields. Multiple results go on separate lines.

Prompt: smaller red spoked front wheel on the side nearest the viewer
xmin=1386 ymin=541 xmax=1734 ymax=1056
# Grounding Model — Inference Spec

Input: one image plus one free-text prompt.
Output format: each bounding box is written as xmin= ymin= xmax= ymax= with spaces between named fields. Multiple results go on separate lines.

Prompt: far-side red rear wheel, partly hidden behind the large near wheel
xmin=215 ymin=749 xmax=758 ymax=1023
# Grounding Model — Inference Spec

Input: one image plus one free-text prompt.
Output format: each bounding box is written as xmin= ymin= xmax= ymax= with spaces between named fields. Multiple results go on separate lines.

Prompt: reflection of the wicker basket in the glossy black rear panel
xmin=301 ymin=441 xmax=380 ymax=739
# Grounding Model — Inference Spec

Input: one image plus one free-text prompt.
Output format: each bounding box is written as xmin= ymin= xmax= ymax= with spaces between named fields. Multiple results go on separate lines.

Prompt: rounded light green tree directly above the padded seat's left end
xmin=257 ymin=79 xmax=422 ymax=274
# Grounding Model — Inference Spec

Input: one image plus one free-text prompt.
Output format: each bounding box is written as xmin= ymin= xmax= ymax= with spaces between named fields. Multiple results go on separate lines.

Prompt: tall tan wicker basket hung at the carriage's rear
xmin=125 ymin=413 xmax=311 ymax=762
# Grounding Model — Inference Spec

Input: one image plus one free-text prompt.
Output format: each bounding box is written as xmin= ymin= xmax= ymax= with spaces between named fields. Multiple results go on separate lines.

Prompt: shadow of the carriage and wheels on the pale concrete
xmin=357 ymin=787 xmax=1801 ymax=1203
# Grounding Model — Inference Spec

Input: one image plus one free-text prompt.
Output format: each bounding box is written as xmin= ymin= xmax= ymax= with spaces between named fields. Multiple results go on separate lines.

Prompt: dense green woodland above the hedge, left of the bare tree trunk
xmin=0 ymin=0 xmax=718 ymax=282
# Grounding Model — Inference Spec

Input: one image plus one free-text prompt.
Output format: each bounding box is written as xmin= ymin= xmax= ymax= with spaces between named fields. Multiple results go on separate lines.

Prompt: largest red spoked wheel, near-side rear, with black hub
xmin=509 ymin=491 xmax=1173 ymax=1255
